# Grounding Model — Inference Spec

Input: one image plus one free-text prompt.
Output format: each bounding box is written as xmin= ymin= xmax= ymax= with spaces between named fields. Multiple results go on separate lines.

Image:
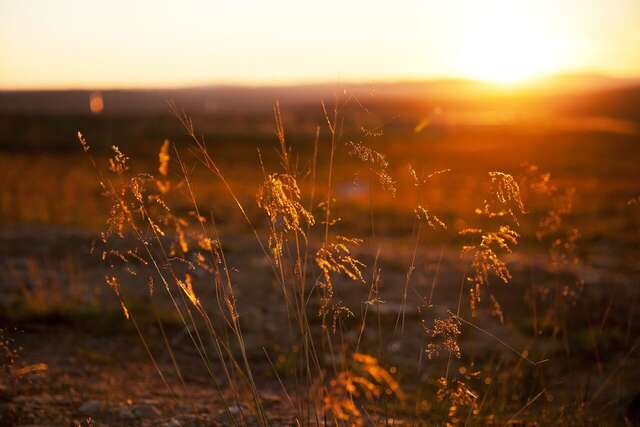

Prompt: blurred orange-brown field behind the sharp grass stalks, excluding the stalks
xmin=0 ymin=82 xmax=640 ymax=426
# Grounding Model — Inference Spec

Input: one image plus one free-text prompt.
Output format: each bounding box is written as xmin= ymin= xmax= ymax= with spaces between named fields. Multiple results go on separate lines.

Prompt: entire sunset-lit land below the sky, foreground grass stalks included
xmin=0 ymin=82 xmax=640 ymax=426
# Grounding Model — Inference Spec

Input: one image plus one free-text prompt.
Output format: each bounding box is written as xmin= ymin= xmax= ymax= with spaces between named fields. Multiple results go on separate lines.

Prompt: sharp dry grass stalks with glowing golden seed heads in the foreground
xmin=41 ymin=97 xmax=636 ymax=425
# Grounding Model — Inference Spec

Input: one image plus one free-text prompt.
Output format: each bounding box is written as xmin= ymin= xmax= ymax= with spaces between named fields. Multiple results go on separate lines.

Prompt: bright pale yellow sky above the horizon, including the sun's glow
xmin=0 ymin=0 xmax=640 ymax=89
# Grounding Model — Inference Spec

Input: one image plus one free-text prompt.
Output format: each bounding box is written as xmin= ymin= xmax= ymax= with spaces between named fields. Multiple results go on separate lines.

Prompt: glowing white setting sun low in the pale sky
xmin=454 ymin=2 xmax=566 ymax=84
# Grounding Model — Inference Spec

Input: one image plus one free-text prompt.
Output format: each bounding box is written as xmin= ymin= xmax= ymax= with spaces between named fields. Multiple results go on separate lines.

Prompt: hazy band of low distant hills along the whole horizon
xmin=0 ymin=73 xmax=640 ymax=114
